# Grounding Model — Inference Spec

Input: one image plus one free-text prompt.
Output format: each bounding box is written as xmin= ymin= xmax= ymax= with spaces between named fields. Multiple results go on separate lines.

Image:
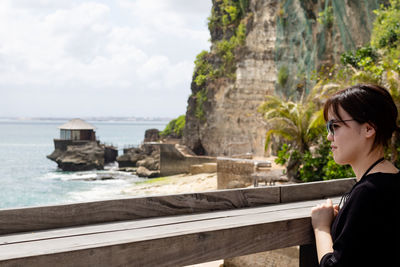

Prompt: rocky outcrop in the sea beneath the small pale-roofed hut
xmin=47 ymin=142 xmax=104 ymax=171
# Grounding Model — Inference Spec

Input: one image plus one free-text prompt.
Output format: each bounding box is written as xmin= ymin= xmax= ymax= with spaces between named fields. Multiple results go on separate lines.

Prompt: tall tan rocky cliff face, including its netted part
xmin=183 ymin=0 xmax=383 ymax=156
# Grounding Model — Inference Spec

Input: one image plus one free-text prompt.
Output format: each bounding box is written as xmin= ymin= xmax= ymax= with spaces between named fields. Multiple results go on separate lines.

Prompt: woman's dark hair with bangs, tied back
xmin=324 ymin=84 xmax=399 ymax=151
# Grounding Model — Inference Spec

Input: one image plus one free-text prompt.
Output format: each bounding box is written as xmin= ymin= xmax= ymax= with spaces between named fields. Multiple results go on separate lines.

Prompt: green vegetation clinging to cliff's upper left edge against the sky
xmin=192 ymin=0 xmax=249 ymax=121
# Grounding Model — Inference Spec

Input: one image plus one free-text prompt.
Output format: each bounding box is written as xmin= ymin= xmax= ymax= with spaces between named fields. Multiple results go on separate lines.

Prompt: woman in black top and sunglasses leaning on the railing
xmin=311 ymin=84 xmax=400 ymax=267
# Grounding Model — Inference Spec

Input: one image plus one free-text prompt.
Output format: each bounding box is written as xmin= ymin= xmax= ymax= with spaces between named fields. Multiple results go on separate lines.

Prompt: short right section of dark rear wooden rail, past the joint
xmin=280 ymin=178 xmax=356 ymax=203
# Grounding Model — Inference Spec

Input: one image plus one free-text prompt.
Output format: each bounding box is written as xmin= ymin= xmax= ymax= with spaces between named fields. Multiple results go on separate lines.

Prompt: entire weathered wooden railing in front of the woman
xmin=0 ymin=179 xmax=355 ymax=267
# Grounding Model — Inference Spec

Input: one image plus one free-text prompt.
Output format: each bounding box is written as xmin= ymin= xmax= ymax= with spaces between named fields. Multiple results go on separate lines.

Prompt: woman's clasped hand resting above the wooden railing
xmin=311 ymin=199 xmax=339 ymax=232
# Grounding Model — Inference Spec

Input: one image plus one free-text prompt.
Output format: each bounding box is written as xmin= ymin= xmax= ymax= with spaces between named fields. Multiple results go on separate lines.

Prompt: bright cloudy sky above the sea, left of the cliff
xmin=0 ymin=0 xmax=211 ymax=118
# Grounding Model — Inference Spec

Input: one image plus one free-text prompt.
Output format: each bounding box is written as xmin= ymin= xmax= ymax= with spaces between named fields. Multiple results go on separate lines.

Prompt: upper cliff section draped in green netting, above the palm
xmin=275 ymin=0 xmax=382 ymax=99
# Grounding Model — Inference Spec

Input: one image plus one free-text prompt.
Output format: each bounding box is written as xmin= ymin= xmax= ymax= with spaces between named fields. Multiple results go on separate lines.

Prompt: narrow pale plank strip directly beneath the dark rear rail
xmin=0 ymin=198 xmax=339 ymax=247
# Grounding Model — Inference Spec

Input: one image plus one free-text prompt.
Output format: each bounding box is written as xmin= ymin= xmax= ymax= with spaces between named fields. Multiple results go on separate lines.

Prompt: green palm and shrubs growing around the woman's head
xmin=259 ymin=0 xmax=400 ymax=182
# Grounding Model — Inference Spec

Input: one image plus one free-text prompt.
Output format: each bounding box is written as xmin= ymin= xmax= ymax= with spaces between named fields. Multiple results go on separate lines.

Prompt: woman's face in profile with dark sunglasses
xmin=327 ymin=106 xmax=365 ymax=165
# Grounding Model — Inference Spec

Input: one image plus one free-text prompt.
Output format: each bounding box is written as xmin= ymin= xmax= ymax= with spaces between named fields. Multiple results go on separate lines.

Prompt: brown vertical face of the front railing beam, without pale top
xmin=2 ymin=220 xmax=309 ymax=267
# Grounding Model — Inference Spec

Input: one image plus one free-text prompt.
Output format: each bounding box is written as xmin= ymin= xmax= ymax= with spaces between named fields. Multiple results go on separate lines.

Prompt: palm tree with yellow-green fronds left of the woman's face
xmin=258 ymin=84 xmax=339 ymax=180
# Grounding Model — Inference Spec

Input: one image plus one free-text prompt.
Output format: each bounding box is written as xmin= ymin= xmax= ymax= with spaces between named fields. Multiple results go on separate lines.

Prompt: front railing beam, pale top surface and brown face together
xmin=0 ymin=207 xmax=313 ymax=266
